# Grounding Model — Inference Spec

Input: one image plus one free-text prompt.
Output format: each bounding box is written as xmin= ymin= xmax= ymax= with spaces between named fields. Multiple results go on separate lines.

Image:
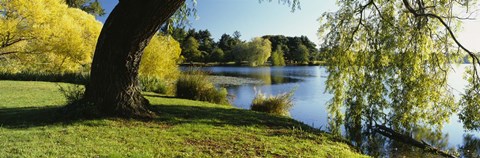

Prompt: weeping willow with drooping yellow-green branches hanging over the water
xmin=319 ymin=0 xmax=480 ymax=131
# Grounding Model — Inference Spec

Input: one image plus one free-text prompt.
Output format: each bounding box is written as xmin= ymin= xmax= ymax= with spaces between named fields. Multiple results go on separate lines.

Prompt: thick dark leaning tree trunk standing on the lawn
xmin=84 ymin=0 xmax=185 ymax=118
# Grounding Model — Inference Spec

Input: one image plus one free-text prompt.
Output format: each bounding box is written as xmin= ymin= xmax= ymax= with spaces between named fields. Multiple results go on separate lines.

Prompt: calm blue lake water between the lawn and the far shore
xmin=197 ymin=65 xmax=480 ymax=157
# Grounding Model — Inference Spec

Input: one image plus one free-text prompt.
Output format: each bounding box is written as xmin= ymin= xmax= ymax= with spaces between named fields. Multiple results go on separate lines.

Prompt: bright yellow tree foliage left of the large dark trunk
xmin=0 ymin=0 xmax=102 ymax=73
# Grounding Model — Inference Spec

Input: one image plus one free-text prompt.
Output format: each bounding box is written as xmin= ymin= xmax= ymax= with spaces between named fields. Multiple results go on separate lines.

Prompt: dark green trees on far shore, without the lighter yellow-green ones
xmin=171 ymin=28 xmax=318 ymax=66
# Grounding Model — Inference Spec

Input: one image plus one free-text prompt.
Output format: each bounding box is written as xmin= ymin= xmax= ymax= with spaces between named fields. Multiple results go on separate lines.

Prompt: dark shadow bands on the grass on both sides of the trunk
xmin=0 ymin=99 xmax=319 ymax=135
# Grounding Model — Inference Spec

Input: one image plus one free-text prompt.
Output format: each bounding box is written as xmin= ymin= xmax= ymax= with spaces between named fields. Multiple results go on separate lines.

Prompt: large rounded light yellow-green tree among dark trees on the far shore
xmin=233 ymin=37 xmax=272 ymax=66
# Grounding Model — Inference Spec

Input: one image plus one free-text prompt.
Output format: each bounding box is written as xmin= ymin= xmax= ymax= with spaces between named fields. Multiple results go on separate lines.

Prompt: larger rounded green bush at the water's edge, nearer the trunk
xmin=175 ymin=71 xmax=229 ymax=104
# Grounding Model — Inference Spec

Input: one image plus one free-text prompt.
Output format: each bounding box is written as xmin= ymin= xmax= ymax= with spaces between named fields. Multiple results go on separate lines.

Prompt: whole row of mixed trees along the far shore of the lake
xmin=170 ymin=28 xmax=322 ymax=66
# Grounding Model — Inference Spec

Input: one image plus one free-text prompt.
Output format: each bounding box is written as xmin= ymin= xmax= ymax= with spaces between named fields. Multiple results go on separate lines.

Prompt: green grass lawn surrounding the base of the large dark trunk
xmin=0 ymin=81 xmax=368 ymax=157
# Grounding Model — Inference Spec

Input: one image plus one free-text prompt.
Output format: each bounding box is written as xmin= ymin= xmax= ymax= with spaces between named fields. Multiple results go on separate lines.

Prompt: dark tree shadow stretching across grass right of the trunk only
xmin=148 ymin=105 xmax=318 ymax=131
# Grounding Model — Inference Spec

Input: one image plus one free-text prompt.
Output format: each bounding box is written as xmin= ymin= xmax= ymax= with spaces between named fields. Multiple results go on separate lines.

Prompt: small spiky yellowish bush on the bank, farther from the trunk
xmin=250 ymin=89 xmax=295 ymax=116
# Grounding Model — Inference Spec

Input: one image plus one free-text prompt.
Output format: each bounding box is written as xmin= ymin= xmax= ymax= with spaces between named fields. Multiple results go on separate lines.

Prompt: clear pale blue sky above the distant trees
xmin=98 ymin=0 xmax=480 ymax=51
